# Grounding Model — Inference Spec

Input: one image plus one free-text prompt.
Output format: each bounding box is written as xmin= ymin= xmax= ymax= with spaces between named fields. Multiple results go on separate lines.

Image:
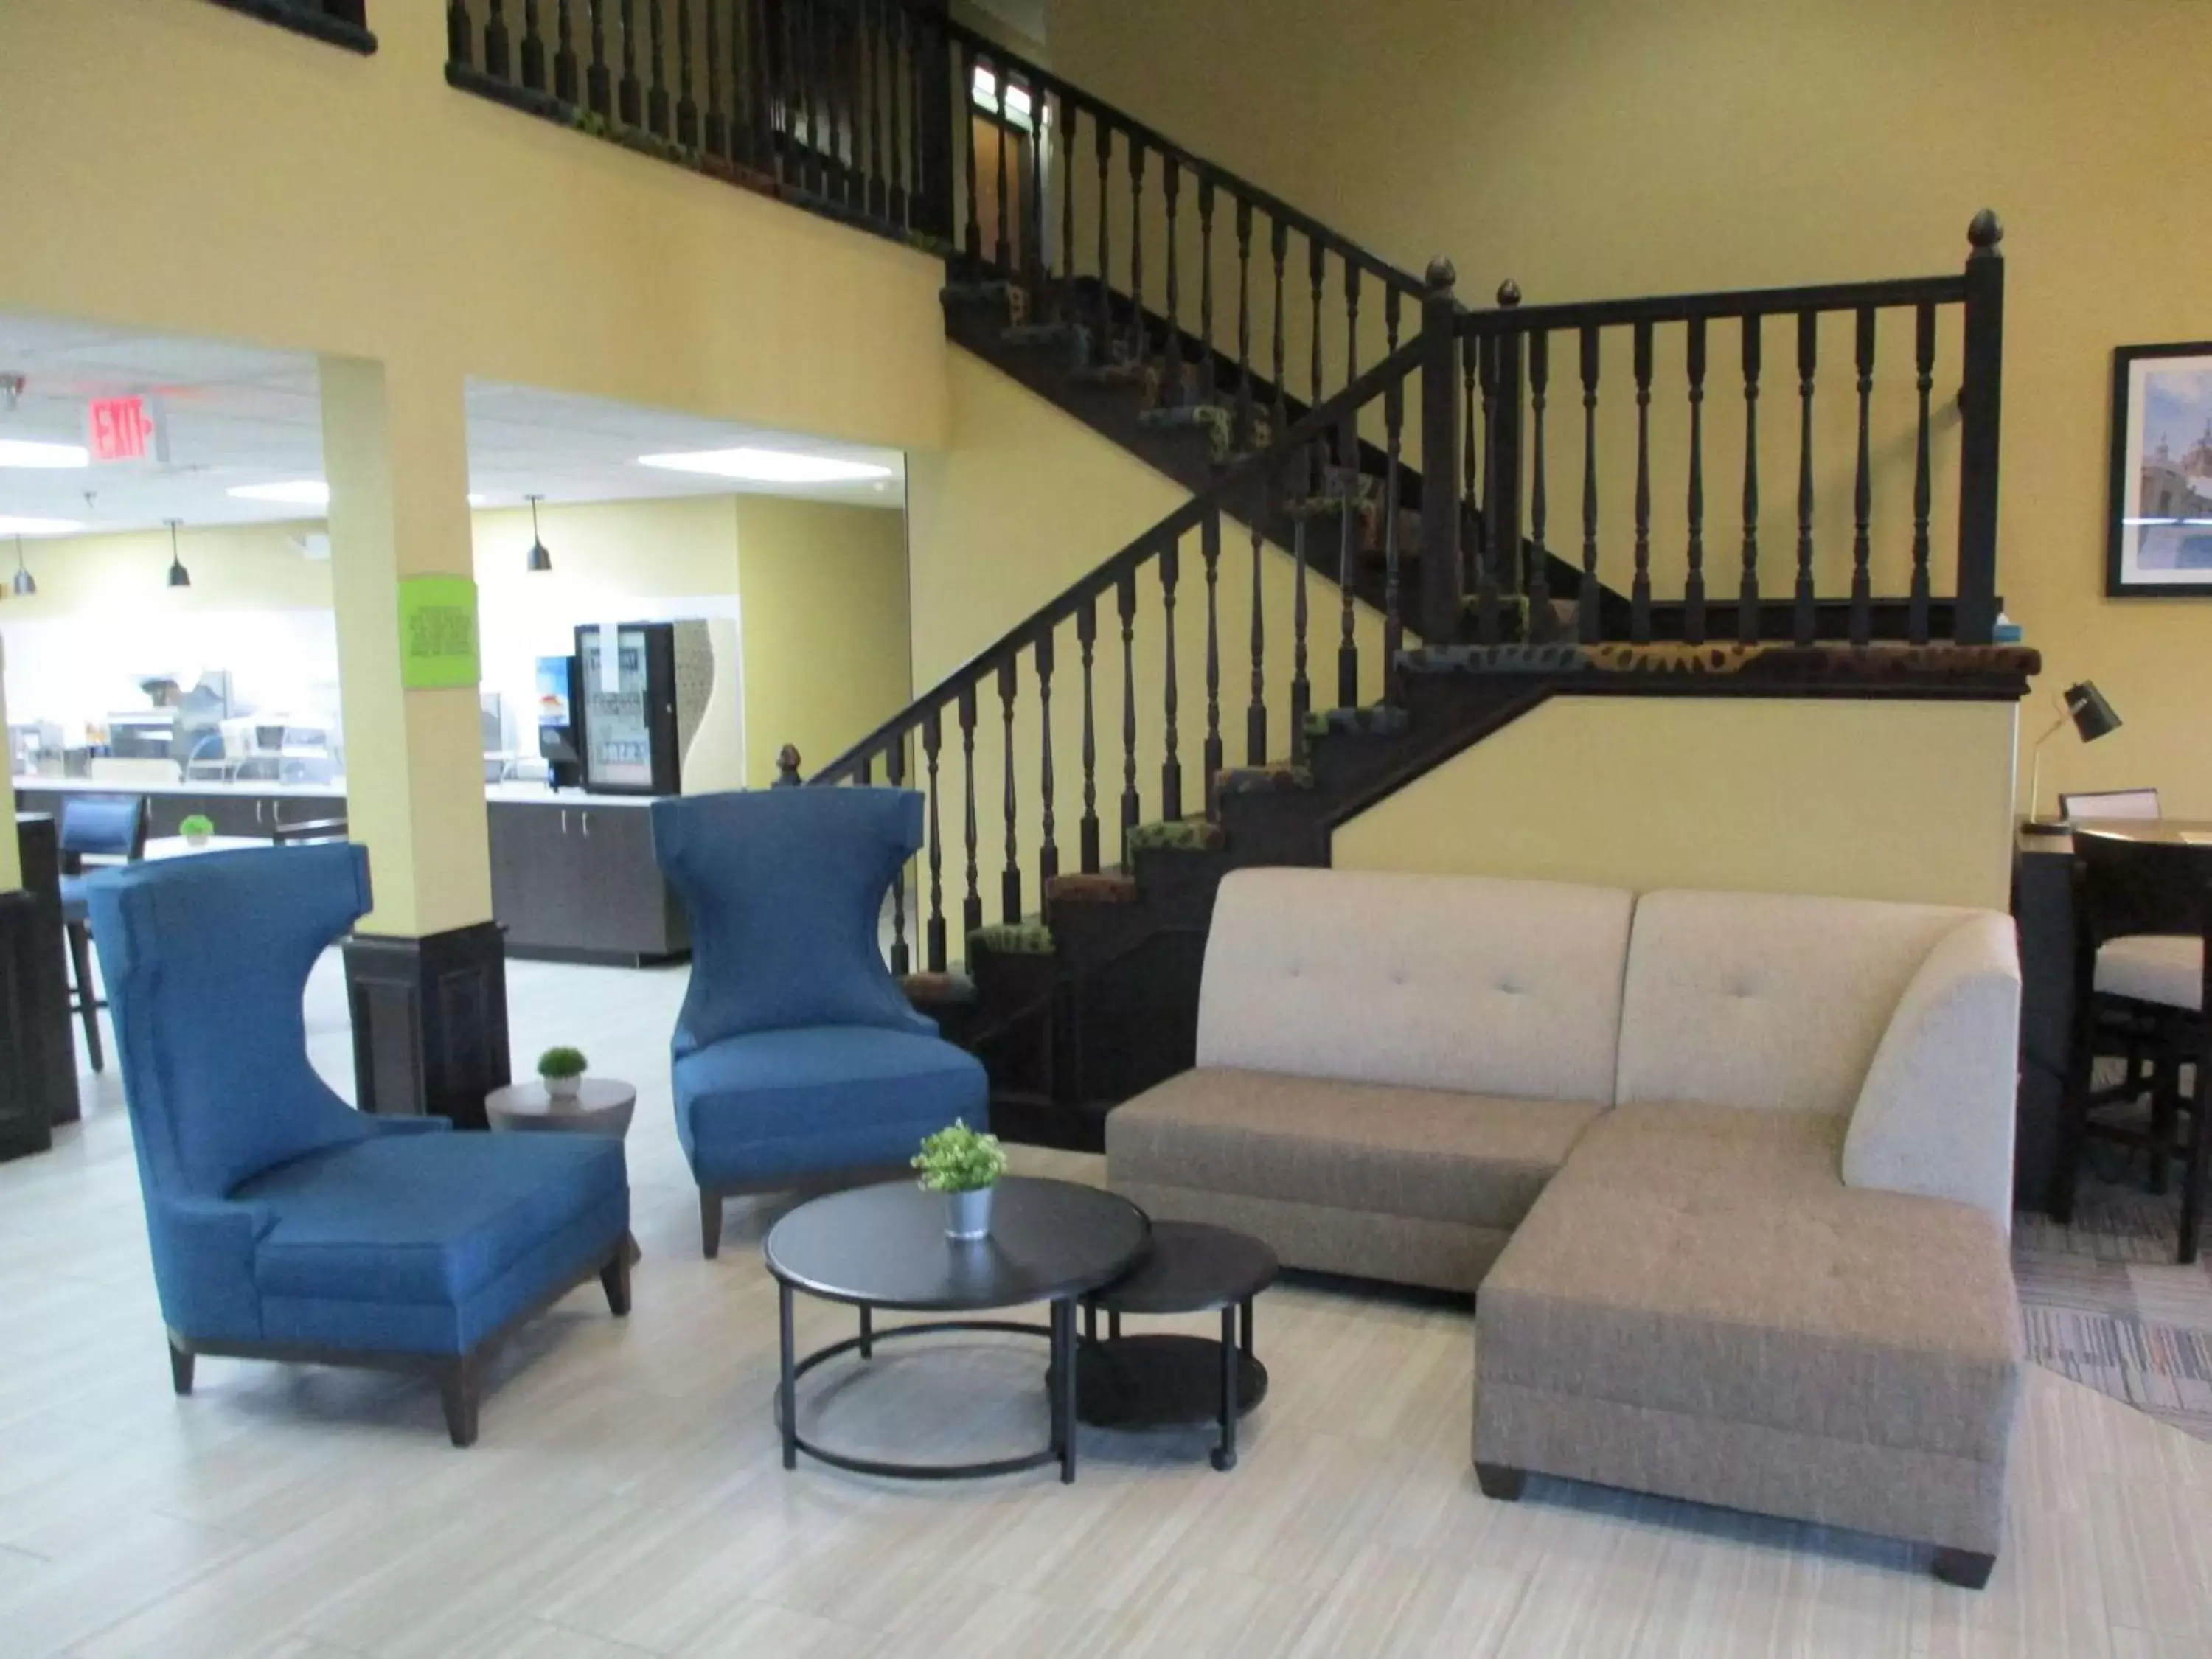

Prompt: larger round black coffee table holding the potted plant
xmin=761 ymin=1179 xmax=1150 ymax=1480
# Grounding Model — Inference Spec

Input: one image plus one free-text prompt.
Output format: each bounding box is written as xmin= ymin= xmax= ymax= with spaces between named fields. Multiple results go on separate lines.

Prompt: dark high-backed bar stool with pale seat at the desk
xmin=2051 ymin=830 xmax=2212 ymax=1263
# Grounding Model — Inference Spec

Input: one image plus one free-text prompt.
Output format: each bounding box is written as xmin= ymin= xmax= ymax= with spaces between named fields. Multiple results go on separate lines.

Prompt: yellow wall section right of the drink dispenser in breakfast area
xmin=737 ymin=495 xmax=911 ymax=787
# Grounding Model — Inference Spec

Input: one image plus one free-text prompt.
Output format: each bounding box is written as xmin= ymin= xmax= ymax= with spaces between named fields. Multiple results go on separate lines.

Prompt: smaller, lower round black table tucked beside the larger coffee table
xmin=1075 ymin=1221 xmax=1276 ymax=1469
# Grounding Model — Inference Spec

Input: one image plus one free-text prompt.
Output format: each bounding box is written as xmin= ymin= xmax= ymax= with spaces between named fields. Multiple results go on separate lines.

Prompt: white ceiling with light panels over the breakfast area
xmin=0 ymin=314 xmax=905 ymax=531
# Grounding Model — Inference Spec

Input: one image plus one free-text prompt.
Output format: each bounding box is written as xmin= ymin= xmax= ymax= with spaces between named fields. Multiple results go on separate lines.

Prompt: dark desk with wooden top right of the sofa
xmin=2013 ymin=818 xmax=2212 ymax=1210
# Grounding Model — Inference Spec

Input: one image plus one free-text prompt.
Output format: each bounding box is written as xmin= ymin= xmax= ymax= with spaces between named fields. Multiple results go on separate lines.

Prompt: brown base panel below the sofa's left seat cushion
xmin=1113 ymin=1181 xmax=1511 ymax=1294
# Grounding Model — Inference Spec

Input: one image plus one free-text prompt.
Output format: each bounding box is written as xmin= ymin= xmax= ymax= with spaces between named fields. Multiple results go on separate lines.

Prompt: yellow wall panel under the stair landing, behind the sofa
xmin=1334 ymin=697 xmax=2015 ymax=909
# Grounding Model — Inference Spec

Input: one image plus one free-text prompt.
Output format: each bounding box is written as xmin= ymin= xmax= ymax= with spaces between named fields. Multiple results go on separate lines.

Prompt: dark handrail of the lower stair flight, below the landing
xmin=807 ymin=338 xmax=1429 ymax=783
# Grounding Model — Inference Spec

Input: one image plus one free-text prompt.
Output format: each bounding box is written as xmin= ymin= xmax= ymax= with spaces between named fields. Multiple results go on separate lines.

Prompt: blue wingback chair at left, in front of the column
xmin=86 ymin=843 xmax=630 ymax=1447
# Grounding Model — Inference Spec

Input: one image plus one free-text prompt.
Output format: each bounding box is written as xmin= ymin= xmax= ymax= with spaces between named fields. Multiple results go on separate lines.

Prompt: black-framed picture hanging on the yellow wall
xmin=2104 ymin=341 xmax=2212 ymax=599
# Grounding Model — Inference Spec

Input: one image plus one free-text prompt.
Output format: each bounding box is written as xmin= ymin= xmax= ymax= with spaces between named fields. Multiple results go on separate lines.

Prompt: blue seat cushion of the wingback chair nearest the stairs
xmin=675 ymin=1026 xmax=989 ymax=1186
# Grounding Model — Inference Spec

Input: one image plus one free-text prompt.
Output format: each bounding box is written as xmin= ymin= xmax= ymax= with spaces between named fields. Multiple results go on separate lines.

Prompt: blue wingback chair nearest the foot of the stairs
xmin=653 ymin=790 xmax=991 ymax=1256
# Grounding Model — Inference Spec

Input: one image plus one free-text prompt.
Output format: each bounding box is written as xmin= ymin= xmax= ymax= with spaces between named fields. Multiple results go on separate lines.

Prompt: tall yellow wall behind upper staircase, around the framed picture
xmin=1048 ymin=0 xmax=2212 ymax=816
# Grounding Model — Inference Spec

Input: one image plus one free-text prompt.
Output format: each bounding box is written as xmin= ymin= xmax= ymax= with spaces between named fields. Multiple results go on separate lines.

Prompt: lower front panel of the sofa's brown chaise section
xmin=1475 ymin=1378 xmax=2004 ymax=1584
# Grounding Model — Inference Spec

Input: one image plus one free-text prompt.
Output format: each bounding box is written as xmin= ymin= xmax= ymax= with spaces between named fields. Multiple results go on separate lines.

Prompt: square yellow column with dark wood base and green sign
xmin=321 ymin=356 xmax=511 ymax=1128
